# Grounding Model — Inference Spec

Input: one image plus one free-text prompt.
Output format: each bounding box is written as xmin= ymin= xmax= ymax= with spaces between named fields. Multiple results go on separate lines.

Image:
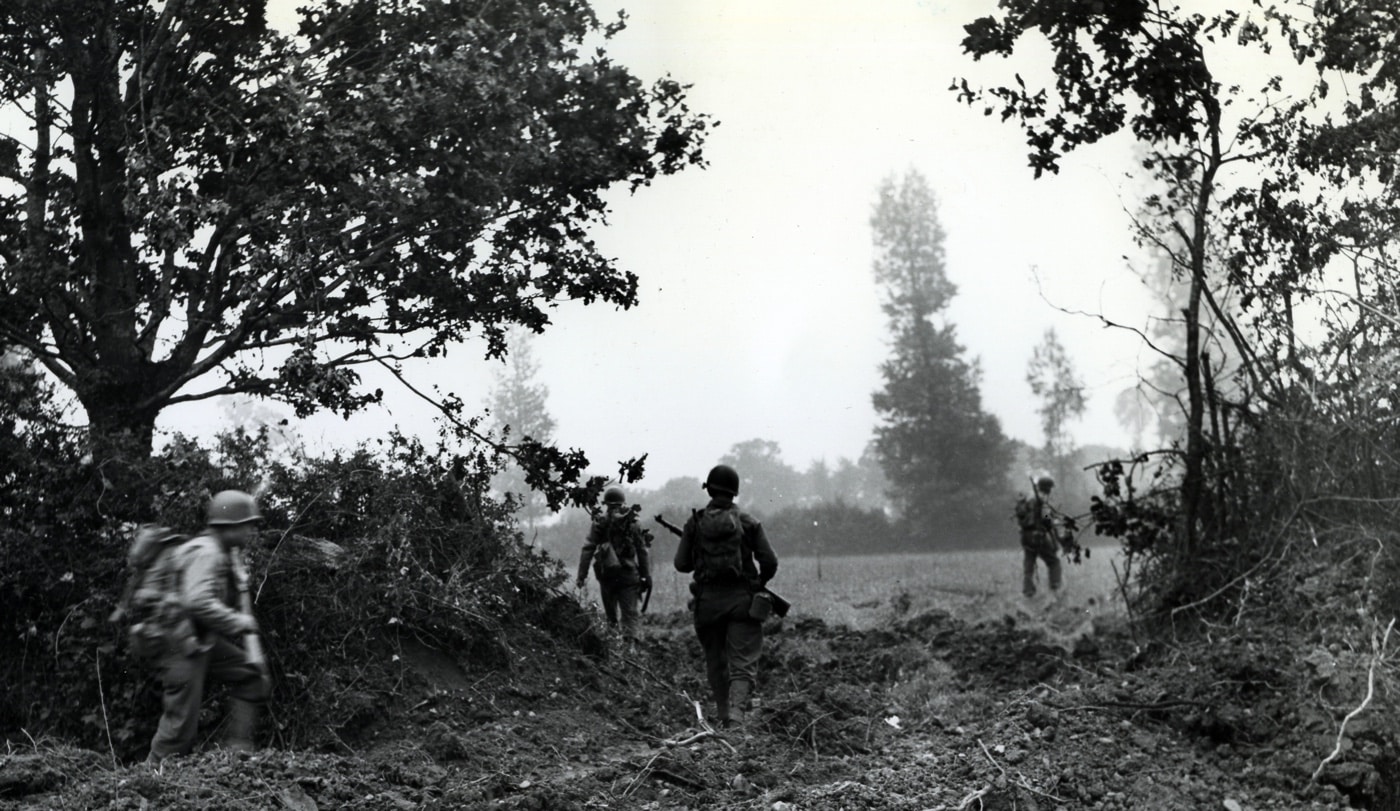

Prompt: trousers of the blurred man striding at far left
xmin=151 ymin=635 xmax=272 ymax=761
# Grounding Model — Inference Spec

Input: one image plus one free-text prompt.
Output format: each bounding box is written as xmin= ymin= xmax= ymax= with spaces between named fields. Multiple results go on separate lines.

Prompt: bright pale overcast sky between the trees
xmin=162 ymin=0 xmax=1170 ymax=486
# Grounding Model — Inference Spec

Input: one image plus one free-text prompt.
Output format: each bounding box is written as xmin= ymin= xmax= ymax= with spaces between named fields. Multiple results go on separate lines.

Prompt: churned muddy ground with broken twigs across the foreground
xmin=0 ymin=582 xmax=1389 ymax=811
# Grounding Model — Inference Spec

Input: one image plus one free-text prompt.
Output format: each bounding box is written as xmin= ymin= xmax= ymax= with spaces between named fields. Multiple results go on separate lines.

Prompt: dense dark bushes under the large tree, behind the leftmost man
xmin=0 ymin=411 xmax=592 ymax=758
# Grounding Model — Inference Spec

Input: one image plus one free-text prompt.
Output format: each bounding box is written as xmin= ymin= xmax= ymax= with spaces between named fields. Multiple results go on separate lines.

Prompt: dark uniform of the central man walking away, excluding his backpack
xmin=675 ymin=476 xmax=778 ymax=723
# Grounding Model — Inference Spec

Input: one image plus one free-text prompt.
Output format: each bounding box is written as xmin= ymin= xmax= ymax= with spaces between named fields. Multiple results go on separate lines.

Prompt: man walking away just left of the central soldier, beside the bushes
xmin=577 ymin=486 xmax=651 ymax=642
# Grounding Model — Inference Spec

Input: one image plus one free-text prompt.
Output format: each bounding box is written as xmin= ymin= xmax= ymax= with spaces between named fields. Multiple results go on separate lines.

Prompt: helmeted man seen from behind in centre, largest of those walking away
xmin=676 ymin=465 xmax=778 ymax=727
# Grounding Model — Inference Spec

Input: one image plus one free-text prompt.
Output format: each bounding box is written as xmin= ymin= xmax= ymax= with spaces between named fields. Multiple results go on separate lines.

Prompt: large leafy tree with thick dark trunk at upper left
xmin=0 ymin=0 xmax=707 ymax=473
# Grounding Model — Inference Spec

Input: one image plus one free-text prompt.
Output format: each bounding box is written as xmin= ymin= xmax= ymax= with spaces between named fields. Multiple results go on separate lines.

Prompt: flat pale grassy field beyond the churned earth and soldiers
xmin=574 ymin=542 xmax=1120 ymax=630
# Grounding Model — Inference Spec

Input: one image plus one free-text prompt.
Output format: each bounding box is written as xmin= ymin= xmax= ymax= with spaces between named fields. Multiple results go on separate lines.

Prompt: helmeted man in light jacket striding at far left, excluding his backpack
xmin=147 ymin=490 xmax=272 ymax=762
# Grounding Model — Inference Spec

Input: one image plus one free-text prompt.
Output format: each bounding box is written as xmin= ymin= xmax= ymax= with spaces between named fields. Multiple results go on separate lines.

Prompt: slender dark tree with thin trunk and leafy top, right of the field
xmin=953 ymin=0 xmax=1296 ymax=559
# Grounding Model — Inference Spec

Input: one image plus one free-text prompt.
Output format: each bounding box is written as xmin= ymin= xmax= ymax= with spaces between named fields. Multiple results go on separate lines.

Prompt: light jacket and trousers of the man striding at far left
xmin=151 ymin=534 xmax=272 ymax=761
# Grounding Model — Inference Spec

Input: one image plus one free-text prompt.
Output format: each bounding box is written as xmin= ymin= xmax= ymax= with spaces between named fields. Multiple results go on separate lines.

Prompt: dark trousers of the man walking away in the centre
xmin=694 ymin=585 xmax=763 ymax=720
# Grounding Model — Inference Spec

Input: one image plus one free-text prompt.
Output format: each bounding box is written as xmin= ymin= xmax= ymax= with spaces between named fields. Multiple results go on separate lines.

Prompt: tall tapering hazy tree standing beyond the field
xmin=871 ymin=171 xmax=1011 ymax=542
